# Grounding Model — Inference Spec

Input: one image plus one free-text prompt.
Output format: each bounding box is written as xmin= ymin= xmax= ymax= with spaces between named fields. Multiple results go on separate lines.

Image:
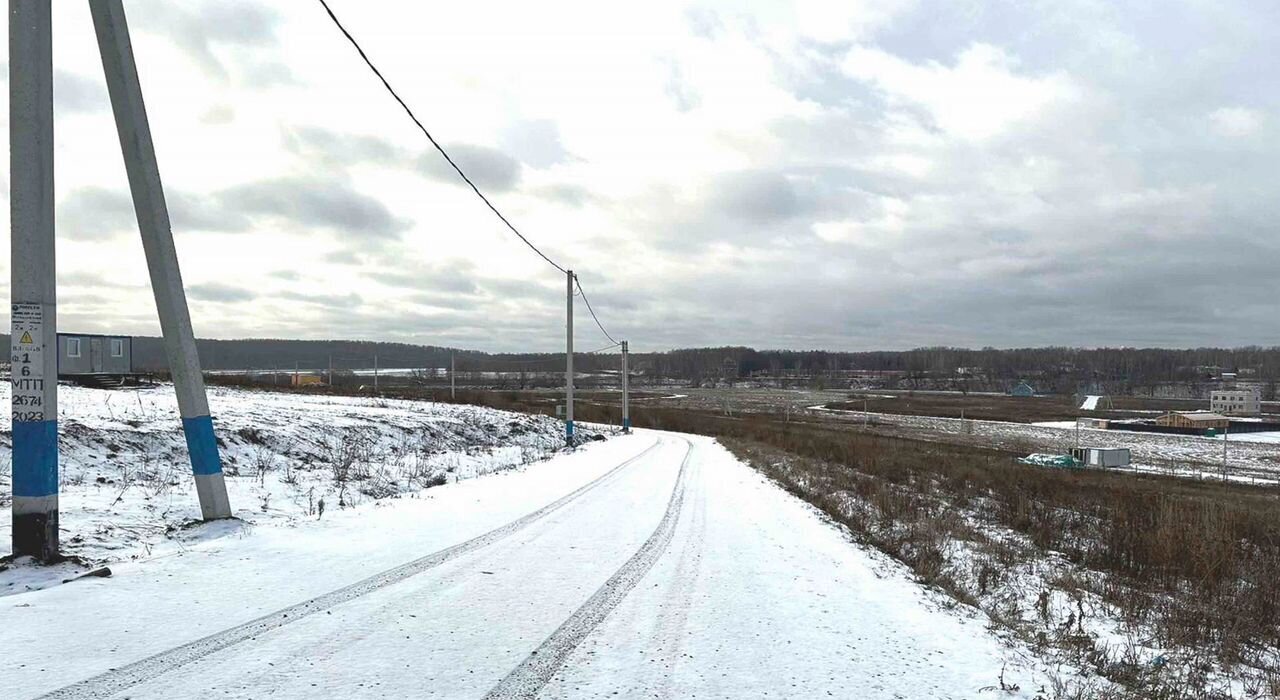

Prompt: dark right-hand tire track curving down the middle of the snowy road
xmin=485 ymin=440 xmax=694 ymax=700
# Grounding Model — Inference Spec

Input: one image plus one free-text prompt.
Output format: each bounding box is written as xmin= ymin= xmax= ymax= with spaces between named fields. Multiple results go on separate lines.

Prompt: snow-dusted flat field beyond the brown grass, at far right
xmin=810 ymin=406 xmax=1280 ymax=484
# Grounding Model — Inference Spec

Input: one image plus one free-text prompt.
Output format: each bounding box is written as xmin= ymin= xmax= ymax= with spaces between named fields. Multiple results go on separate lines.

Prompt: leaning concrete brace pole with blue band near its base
xmin=88 ymin=0 xmax=232 ymax=520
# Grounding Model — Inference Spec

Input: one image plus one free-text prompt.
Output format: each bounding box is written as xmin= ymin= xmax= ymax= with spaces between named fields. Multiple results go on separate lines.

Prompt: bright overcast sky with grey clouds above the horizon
xmin=0 ymin=0 xmax=1280 ymax=351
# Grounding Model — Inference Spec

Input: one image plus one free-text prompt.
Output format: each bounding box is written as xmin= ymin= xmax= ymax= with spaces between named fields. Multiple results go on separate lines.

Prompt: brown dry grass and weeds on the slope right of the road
xmin=204 ymin=381 xmax=1280 ymax=699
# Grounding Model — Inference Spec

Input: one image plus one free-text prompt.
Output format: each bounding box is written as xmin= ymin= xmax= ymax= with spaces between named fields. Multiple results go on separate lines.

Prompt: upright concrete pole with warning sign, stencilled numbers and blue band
xmin=9 ymin=0 xmax=59 ymax=562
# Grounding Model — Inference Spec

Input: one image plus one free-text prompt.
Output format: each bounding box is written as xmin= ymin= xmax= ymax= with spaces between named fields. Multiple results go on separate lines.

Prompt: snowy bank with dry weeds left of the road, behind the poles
xmin=0 ymin=384 xmax=601 ymax=586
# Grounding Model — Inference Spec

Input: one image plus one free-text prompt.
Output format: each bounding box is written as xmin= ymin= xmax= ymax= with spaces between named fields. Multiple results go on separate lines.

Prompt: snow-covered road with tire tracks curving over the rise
xmin=10 ymin=431 xmax=1037 ymax=699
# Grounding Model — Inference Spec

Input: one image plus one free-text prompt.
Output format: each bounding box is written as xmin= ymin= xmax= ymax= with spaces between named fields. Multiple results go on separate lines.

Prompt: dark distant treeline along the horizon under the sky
xmin=0 ymin=335 xmax=1280 ymax=390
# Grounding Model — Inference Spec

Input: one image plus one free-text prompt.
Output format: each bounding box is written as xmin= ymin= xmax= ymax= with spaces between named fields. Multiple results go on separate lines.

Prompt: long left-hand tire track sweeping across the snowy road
xmin=40 ymin=440 xmax=665 ymax=700
